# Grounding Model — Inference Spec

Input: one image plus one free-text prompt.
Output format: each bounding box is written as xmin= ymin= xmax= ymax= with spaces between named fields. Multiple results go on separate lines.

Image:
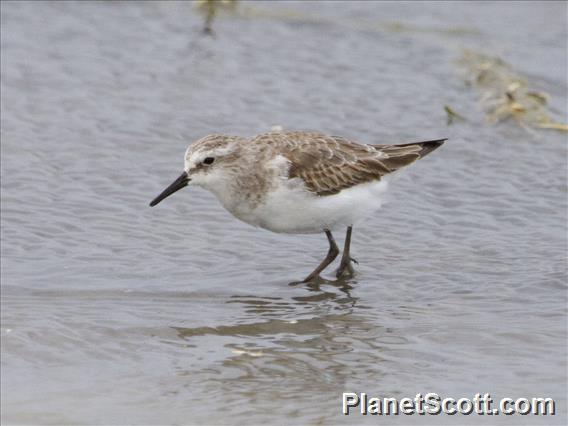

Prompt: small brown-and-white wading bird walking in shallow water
xmin=150 ymin=132 xmax=446 ymax=282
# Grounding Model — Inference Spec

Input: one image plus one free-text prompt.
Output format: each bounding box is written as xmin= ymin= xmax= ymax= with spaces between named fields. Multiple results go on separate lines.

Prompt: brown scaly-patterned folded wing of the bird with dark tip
xmin=280 ymin=132 xmax=444 ymax=196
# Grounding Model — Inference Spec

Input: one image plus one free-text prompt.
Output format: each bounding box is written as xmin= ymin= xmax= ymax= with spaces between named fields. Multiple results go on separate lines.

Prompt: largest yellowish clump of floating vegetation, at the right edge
xmin=460 ymin=50 xmax=568 ymax=132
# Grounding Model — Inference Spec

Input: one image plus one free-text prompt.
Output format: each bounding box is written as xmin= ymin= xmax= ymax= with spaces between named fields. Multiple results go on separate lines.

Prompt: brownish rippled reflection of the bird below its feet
xmin=171 ymin=279 xmax=388 ymax=401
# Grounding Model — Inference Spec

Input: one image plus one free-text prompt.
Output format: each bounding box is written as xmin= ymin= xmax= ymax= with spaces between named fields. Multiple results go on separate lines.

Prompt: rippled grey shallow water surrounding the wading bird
xmin=1 ymin=2 xmax=567 ymax=424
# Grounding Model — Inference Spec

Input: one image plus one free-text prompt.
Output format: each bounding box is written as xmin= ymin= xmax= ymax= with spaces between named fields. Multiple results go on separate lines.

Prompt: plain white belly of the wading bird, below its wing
xmin=240 ymin=179 xmax=388 ymax=234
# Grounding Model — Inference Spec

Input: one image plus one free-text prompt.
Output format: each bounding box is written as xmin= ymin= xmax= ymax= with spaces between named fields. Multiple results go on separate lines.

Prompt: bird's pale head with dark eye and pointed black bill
xmin=150 ymin=135 xmax=239 ymax=207
